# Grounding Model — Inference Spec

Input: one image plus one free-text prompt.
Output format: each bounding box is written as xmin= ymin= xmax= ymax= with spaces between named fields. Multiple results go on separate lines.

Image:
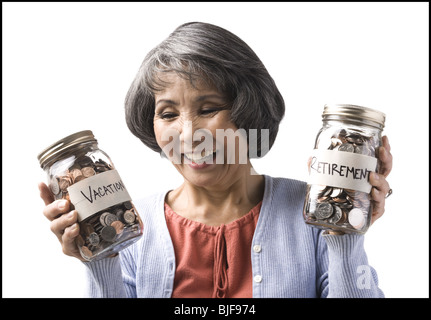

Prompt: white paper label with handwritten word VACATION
xmin=67 ymin=170 xmax=132 ymax=221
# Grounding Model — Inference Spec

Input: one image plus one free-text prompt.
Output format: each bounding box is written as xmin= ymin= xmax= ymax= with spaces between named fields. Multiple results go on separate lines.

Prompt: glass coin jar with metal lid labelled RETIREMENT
xmin=303 ymin=104 xmax=386 ymax=234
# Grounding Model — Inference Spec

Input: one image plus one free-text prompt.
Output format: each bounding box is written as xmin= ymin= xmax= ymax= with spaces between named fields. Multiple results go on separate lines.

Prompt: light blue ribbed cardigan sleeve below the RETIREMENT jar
xmin=316 ymin=232 xmax=384 ymax=298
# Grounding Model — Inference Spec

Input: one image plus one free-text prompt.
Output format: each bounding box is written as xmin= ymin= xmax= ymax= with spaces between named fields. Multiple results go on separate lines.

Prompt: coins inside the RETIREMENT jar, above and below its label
xmin=304 ymin=129 xmax=378 ymax=232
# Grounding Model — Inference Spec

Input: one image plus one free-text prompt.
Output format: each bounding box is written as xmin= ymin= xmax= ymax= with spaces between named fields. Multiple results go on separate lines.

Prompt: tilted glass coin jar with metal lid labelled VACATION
xmin=37 ymin=130 xmax=143 ymax=261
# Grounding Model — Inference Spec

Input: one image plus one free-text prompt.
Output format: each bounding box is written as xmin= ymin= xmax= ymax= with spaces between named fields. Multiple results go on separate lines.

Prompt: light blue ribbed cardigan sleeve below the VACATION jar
xmin=83 ymin=250 xmax=136 ymax=298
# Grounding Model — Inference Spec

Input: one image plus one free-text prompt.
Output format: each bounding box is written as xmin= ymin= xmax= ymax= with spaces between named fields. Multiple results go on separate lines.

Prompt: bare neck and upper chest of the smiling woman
xmin=166 ymin=165 xmax=265 ymax=226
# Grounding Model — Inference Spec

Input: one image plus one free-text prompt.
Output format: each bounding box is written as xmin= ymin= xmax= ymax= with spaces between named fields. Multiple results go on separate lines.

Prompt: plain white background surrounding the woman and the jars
xmin=2 ymin=3 xmax=429 ymax=297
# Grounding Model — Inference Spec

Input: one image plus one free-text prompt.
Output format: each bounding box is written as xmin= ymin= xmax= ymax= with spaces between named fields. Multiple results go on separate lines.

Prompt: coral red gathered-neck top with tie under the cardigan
xmin=165 ymin=201 xmax=262 ymax=298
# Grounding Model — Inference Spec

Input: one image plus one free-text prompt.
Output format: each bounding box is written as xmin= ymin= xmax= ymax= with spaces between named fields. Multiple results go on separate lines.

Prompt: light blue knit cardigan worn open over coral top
xmin=83 ymin=176 xmax=383 ymax=298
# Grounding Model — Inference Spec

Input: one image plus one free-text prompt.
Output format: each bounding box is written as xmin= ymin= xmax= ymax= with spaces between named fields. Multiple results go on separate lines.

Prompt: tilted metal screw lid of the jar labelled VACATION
xmin=37 ymin=130 xmax=97 ymax=168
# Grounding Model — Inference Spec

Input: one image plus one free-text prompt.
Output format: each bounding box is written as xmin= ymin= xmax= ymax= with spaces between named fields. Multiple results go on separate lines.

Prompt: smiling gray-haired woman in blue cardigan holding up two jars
xmin=39 ymin=23 xmax=392 ymax=297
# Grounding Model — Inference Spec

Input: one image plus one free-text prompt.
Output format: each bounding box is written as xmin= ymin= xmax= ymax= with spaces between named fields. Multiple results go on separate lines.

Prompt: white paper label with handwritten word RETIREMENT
xmin=309 ymin=149 xmax=377 ymax=193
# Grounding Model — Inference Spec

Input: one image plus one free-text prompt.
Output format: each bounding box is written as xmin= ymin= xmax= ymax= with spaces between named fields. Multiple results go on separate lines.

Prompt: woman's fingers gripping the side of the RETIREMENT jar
xmin=370 ymin=136 xmax=392 ymax=224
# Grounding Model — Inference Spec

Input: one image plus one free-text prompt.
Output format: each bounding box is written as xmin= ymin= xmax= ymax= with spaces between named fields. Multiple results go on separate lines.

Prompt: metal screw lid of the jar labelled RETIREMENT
xmin=322 ymin=104 xmax=386 ymax=129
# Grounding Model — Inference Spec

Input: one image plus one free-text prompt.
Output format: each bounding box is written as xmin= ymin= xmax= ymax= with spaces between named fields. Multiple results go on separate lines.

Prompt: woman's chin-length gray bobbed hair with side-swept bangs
xmin=125 ymin=22 xmax=285 ymax=157
